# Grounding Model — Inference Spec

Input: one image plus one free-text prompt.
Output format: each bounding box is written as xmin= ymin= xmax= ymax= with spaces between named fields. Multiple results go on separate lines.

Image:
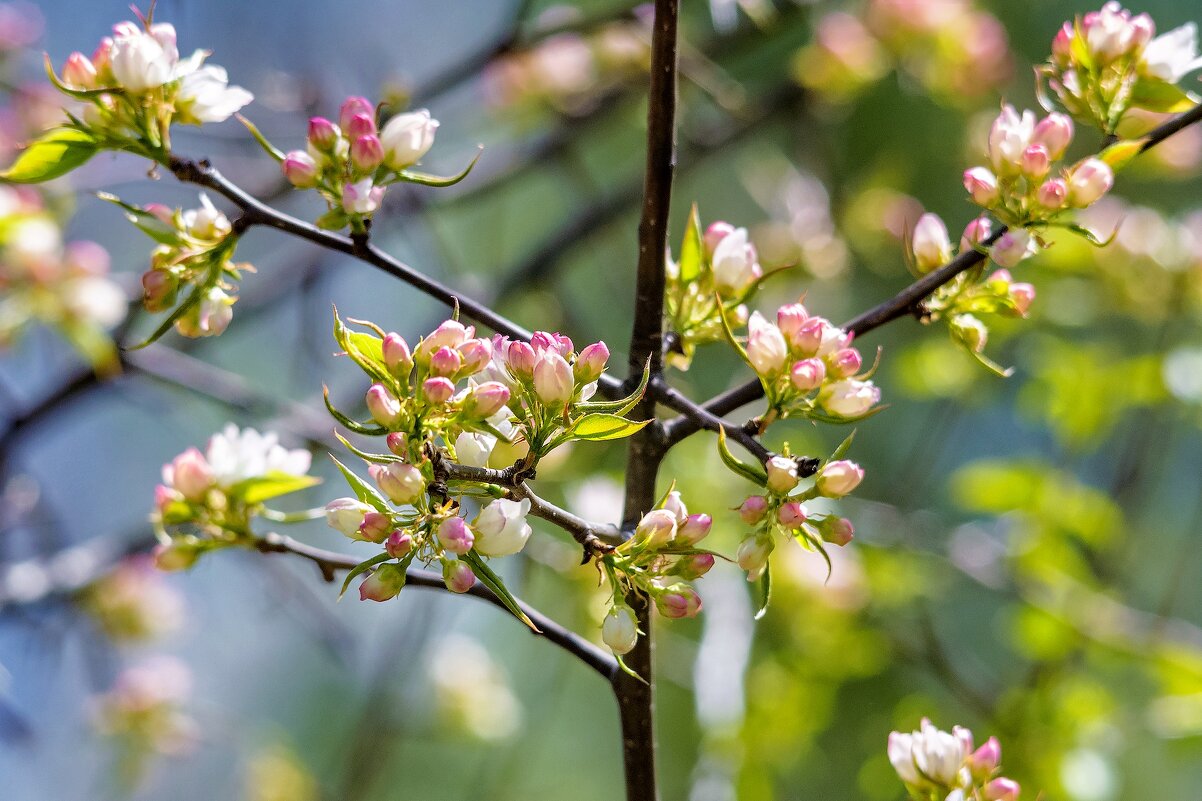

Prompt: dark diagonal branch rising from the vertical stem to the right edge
xmin=665 ymin=105 xmax=1202 ymax=444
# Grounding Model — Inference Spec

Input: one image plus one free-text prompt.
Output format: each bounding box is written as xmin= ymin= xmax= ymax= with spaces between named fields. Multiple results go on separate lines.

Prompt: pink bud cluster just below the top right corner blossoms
xmin=964 ymin=106 xmax=1114 ymax=234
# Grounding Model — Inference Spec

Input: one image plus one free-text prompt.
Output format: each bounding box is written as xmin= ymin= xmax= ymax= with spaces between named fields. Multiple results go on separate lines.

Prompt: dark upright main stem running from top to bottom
xmin=613 ymin=0 xmax=679 ymax=801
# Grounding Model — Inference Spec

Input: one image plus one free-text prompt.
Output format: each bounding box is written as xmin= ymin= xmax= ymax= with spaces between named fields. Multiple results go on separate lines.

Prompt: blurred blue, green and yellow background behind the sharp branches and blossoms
xmin=0 ymin=0 xmax=1202 ymax=801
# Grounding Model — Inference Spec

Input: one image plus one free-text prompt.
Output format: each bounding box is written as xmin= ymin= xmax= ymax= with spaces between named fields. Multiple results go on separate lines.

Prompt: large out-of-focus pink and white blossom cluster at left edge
xmin=0 ymin=186 xmax=129 ymax=369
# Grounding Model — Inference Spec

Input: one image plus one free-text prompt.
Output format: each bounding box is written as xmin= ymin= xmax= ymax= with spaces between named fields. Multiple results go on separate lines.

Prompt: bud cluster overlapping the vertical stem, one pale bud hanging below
xmin=600 ymin=490 xmax=714 ymax=657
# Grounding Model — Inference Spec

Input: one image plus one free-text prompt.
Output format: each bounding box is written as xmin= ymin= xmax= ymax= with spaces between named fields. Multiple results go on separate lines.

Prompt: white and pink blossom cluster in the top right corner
xmin=1037 ymin=1 xmax=1202 ymax=134
